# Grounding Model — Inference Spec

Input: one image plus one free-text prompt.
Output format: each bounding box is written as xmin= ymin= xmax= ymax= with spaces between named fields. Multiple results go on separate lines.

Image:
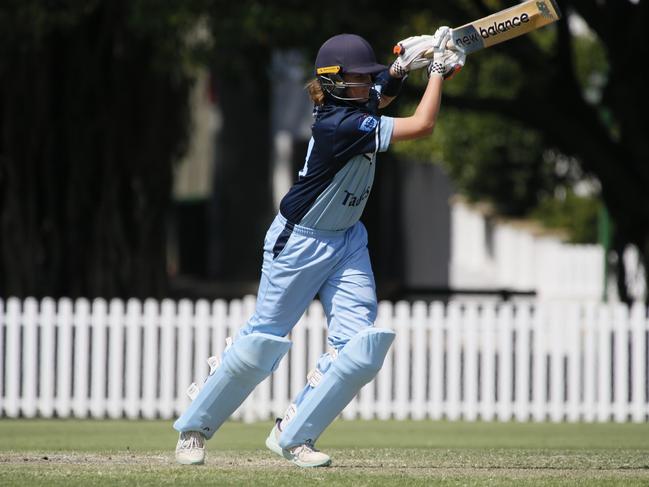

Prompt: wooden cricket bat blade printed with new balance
xmin=449 ymin=0 xmax=561 ymax=54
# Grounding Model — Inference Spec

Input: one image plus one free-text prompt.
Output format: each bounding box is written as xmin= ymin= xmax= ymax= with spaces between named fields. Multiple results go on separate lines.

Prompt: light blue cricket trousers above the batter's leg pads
xmin=239 ymin=214 xmax=377 ymax=350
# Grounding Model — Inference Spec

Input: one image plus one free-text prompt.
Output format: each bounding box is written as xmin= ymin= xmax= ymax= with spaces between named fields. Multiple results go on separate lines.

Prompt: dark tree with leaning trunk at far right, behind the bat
xmin=392 ymin=0 xmax=649 ymax=297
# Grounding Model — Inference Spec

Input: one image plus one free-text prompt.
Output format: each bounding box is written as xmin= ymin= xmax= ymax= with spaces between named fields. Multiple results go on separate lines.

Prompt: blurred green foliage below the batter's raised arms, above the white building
xmin=398 ymin=109 xmax=556 ymax=217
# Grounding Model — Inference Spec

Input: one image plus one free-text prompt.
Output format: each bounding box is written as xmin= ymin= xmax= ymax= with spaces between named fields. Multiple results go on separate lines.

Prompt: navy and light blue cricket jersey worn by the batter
xmin=280 ymin=104 xmax=394 ymax=230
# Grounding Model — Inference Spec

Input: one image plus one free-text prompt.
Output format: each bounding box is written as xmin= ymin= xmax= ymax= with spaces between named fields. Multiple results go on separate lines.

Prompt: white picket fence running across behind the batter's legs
xmin=0 ymin=297 xmax=649 ymax=422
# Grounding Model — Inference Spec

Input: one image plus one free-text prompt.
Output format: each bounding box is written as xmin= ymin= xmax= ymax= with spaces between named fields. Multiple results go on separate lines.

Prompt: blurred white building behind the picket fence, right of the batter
xmin=449 ymin=198 xmax=605 ymax=300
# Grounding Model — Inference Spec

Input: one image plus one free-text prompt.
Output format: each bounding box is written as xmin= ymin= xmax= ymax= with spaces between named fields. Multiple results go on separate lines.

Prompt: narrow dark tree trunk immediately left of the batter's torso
xmin=209 ymin=46 xmax=273 ymax=281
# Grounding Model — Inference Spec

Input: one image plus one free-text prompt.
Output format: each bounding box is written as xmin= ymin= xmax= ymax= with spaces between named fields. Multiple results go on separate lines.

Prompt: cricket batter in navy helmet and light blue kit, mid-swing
xmin=174 ymin=27 xmax=465 ymax=467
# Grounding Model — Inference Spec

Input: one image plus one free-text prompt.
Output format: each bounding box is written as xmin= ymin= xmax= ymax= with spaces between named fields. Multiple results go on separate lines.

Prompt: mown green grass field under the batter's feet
xmin=0 ymin=419 xmax=649 ymax=487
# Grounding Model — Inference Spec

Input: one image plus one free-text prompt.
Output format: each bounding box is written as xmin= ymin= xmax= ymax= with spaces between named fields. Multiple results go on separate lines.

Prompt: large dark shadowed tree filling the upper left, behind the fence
xmin=0 ymin=0 xmax=205 ymax=298
